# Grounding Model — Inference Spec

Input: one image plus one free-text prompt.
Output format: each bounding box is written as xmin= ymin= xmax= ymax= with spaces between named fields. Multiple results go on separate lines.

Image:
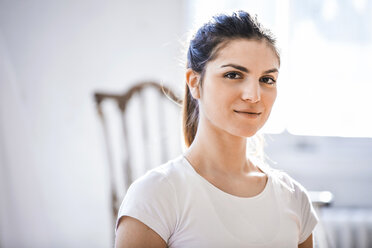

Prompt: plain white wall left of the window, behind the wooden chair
xmin=0 ymin=0 xmax=186 ymax=247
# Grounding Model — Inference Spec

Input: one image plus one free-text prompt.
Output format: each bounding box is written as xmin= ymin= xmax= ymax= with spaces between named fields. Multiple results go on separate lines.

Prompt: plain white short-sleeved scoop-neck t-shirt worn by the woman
xmin=116 ymin=156 xmax=318 ymax=248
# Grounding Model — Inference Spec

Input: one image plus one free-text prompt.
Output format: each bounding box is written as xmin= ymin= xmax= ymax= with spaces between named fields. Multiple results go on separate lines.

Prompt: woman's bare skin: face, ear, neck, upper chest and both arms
xmin=116 ymin=39 xmax=313 ymax=248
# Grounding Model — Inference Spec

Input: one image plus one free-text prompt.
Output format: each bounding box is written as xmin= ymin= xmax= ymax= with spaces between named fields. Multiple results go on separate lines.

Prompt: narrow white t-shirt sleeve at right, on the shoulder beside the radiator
xmin=295 ymin=182 xmax=318 ymax=244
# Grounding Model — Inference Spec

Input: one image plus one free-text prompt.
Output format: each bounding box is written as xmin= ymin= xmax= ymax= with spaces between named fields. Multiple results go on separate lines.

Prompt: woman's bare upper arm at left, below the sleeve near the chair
xmin=115 ymin=216 xmax=167 ymax=248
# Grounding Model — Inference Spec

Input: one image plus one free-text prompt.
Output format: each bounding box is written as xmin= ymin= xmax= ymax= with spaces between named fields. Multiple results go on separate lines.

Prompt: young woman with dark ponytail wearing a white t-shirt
xmin=116 ymin=11 xmax=317 ymax=248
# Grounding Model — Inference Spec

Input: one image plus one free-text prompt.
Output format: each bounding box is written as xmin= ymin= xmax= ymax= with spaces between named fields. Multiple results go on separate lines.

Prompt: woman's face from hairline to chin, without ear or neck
xmin=199 ymin=39 xmax=279 ymax=137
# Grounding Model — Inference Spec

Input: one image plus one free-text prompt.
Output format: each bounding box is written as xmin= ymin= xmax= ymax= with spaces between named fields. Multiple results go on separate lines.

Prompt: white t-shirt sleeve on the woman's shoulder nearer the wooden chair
xmin=115 ymin=171 xmax=176 ymax=243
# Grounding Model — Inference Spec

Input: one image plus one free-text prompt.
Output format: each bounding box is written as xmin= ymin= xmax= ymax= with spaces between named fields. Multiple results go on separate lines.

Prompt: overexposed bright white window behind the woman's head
xmin=189 ymin=0 xmax=372 ymax=137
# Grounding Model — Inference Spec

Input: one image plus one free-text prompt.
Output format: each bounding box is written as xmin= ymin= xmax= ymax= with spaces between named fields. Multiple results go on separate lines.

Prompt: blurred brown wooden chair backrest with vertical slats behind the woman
xmin=94 ymin=82 xmax=182 ymax=227
